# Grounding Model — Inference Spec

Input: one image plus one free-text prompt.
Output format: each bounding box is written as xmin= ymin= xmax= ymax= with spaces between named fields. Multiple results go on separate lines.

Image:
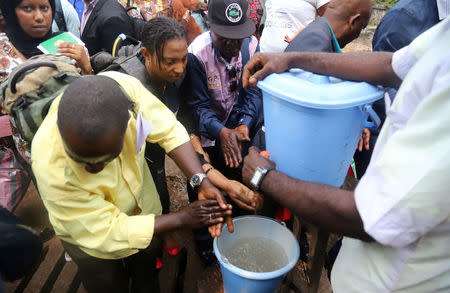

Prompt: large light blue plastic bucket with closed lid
xmin=258 ymin=70 xmax=384 ymax=187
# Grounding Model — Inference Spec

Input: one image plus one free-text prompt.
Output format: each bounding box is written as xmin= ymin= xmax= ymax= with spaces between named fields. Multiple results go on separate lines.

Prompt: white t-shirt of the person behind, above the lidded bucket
xmin=259 ymin=0 xmax=329 ymax=52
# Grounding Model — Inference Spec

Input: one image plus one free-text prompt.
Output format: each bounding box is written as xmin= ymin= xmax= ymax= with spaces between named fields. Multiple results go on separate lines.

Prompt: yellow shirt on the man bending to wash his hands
xmin=31 ymin=72 xmax=189 ymax=259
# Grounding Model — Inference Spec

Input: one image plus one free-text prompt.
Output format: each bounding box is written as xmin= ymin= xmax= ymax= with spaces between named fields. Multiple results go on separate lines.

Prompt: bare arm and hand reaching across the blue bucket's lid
xmin=242 ymin=52 xmax=401 ymax=88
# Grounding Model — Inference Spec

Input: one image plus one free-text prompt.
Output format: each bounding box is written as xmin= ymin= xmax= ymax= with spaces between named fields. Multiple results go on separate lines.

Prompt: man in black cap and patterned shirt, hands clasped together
xmin=187 ymin=0 xmax=262 ymax=176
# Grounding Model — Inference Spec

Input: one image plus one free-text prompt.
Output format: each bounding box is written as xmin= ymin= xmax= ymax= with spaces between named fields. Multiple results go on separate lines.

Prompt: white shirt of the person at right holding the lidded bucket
xmin=331 ymin=18 xmax=450 ymax=293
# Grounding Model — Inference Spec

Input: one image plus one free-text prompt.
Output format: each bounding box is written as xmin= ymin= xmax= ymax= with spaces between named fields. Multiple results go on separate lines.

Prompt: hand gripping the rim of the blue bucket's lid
xmin=242 ymin=52 xmax=290 ymax=88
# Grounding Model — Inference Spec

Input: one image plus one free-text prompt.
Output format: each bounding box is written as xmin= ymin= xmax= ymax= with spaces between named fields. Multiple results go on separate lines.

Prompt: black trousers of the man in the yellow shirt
xmin=61 ymin=240 xmax=159 ymax=293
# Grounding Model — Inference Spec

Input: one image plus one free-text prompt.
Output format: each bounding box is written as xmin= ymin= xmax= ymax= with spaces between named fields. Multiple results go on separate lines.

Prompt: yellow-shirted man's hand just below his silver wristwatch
xmin=198 ymin=179 xmax=234 ymax=238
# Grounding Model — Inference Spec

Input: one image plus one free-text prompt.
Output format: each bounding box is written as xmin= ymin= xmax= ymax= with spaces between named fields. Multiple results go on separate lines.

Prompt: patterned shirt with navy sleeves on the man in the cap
xmin=186 ymin=32 xmax=261 ymax=147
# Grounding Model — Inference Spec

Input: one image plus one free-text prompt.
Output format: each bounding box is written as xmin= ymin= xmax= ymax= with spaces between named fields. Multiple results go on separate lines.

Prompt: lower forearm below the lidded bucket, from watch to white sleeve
xmin=261 ymin=170 xmax=372 ymax=241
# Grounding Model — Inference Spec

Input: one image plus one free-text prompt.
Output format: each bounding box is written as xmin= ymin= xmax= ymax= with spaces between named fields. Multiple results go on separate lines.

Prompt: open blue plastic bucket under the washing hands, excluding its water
xmin=214 ymin=216 xmax=300 ymax=293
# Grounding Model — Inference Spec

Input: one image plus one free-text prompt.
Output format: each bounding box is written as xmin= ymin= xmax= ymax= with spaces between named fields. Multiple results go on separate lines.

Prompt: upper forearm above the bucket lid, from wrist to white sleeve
xmin=286 ymin=52 xmax=401 ymax=88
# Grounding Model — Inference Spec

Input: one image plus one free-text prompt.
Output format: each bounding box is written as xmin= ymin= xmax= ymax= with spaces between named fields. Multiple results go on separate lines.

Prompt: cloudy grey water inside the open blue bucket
xmin=223 ymin=237 xmax=288 ymax=273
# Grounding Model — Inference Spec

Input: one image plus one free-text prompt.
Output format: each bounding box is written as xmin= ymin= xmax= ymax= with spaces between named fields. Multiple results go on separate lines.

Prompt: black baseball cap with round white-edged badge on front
xmin=208 ymin=0 xmax=256 ymax=39
